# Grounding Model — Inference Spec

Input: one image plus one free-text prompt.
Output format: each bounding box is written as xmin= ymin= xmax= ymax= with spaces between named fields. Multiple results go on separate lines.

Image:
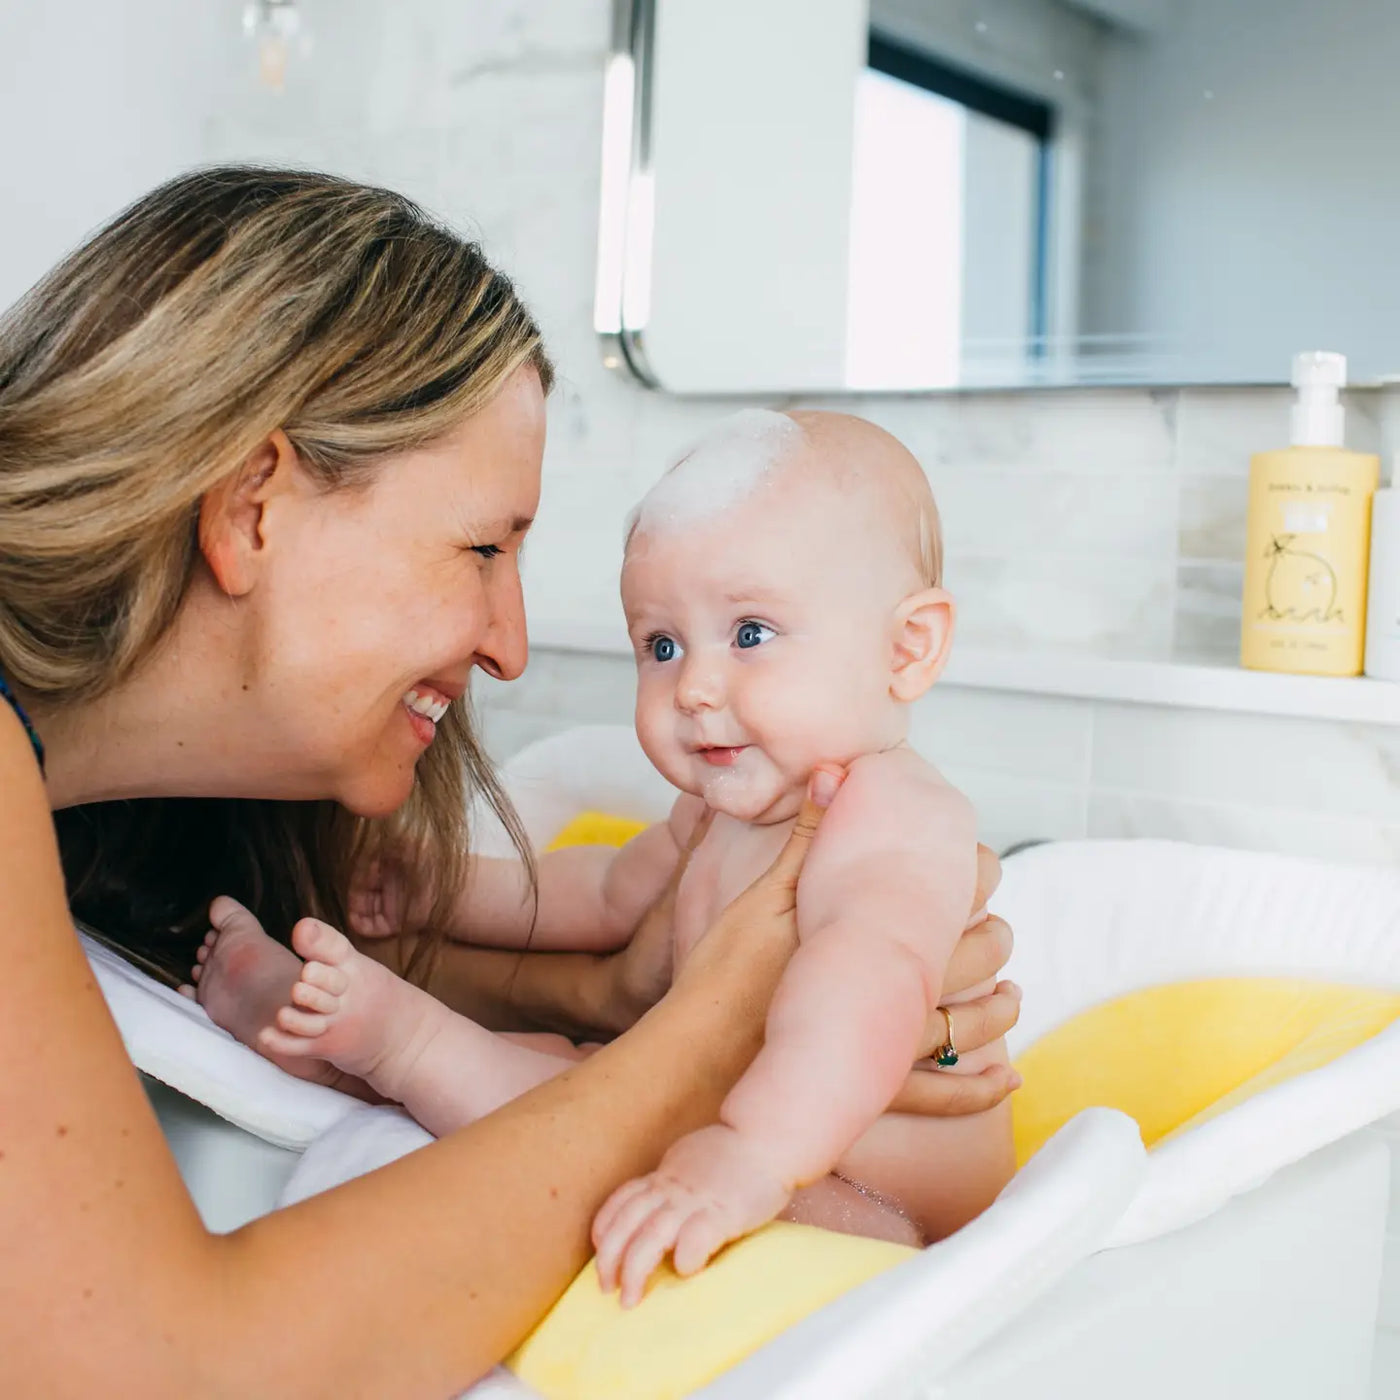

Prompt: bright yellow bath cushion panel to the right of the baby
xmin=1012 ymin=977 xmax=1400 ymax=1165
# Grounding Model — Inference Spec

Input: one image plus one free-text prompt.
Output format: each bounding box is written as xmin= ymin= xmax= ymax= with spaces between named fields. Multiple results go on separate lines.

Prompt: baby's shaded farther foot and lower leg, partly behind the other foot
xmin=179 ymin=896 xmax=367 ymax=1098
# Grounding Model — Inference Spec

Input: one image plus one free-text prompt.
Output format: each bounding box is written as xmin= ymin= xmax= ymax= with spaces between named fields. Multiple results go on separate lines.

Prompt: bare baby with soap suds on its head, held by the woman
xmin=191 ymin=410 xmax=1014 ymax=1303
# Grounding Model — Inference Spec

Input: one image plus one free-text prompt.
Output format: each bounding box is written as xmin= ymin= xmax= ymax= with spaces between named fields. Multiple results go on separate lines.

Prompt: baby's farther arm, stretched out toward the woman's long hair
xmin=350 ymin=797 xmax=703 ymax=952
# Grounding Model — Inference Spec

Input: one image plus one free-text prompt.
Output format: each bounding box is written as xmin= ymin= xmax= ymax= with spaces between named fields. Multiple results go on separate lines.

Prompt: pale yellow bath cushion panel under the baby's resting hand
xmin=507 ymin=1221 xmax=916 ymax=1400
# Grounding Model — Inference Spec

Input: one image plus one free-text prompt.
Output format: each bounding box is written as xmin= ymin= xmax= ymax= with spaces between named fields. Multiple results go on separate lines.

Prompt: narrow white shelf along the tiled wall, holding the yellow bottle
xmin=531 ymin=623 xmax=1400 ymax=725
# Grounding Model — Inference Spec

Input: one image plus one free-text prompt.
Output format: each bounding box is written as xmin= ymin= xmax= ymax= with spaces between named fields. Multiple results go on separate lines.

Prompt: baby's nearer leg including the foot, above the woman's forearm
xmin=258 ymin=918 xmax=573 ymax=1135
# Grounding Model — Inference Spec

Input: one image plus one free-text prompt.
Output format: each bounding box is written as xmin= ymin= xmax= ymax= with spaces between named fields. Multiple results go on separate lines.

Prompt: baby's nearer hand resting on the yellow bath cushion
xmin=594 ymin=1124 xmax=792 ymax=1308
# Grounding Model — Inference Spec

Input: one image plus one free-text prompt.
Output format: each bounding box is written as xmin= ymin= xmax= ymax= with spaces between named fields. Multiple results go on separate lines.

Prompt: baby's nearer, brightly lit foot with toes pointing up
xmin=258 ymin=918 xmax=423 ymax=1099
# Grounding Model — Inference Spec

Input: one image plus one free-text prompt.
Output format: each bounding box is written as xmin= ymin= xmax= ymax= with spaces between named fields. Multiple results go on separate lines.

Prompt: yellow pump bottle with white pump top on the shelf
xmin=1240 ymin=351 xmax=1380 ymax=676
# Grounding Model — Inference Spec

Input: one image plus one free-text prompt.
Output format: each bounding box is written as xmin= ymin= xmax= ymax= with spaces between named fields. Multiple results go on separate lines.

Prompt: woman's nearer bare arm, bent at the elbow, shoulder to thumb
xmin=0 ymin=714 xmax=815 ymax=1396
